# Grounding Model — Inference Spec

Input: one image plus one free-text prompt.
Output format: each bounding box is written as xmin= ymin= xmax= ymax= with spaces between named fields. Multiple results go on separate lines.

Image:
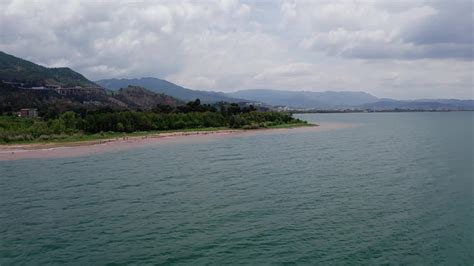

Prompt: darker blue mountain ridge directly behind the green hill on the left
xmin=96 ymin=77 xmax=247 ymax=103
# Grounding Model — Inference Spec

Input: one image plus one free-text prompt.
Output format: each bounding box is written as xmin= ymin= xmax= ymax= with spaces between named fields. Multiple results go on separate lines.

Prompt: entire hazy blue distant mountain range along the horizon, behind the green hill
xmin=96 ymin=77 xmax=474 ymax=110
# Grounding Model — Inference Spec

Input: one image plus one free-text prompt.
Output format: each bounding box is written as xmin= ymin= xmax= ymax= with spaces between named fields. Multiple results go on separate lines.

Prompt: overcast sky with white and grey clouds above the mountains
xmin=0 ymin=0 xmax=474 ymax=99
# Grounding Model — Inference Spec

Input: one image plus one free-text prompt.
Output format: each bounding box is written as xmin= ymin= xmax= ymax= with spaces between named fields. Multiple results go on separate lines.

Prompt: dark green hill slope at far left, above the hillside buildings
xmin=0 ymin=51 xmax=98 ymax=87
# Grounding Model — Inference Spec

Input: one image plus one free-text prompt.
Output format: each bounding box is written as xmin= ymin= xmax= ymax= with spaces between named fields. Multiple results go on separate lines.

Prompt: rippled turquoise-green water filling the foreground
xmin=0 ymin=112 xmax=474 ymax=265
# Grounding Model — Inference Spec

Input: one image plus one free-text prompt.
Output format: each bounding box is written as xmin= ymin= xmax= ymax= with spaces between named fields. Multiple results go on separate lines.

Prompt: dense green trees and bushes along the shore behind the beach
xmin=0 ymin=100 xmax=305 ymax=143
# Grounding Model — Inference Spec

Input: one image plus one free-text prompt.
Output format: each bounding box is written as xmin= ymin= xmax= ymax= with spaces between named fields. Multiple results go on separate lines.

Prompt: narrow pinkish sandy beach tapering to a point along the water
xmin=0 ymin=123 xmax=355 ymax=161
